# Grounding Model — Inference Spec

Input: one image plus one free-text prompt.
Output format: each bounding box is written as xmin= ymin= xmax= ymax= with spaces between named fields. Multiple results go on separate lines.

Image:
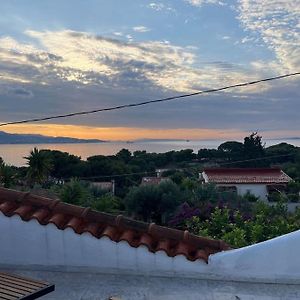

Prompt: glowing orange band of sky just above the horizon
xmin=0 ymin=124 xmax=300 ymax=141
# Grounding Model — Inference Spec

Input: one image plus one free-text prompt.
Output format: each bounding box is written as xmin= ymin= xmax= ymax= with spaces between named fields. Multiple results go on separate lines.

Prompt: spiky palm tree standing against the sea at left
xmin=24 ymin=147 xmax=53 ymax=184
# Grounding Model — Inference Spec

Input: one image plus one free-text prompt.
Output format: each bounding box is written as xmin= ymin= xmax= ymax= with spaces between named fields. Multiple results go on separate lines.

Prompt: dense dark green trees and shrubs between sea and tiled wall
xmin=0 ymin=133 xmax=300 ymax=247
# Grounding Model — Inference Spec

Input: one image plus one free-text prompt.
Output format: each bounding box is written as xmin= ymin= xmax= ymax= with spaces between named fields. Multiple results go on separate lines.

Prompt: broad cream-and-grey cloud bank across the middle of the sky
xmin=0 ymin=30 xmax=300 ymax=137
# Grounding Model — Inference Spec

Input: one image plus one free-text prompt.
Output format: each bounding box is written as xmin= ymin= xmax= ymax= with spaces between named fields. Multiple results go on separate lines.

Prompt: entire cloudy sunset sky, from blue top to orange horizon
xmin=0 ymin=0 xmax=300 ymax=140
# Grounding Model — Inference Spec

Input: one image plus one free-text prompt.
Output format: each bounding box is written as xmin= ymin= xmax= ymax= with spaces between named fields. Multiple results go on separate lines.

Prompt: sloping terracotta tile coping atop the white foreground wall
xmin=0 ymin=188 xmax=230 ymax=262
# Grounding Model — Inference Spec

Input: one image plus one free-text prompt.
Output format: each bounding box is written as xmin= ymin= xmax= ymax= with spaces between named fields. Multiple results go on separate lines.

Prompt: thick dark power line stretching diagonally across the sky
xmin=0 ymin=72 xmax=300 ymax=127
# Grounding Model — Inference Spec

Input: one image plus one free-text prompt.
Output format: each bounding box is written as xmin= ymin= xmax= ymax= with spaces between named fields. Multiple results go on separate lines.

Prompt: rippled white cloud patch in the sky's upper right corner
xmin=238 ymin=0 xmax=300 ymax=72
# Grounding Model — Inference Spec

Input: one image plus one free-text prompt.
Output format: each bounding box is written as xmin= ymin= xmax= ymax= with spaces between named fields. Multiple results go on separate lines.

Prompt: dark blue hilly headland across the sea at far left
xmin=0 ymin=131 xmax=106 ymax=144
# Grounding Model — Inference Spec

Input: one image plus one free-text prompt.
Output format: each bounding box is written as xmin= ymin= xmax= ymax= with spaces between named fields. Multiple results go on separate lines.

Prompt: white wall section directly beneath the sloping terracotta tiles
xmin=0 ymin=213 xmax=208 ymax=274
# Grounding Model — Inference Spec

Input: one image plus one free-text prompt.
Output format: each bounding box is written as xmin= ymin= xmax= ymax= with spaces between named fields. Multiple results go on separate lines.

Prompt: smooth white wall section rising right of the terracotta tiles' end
xmin=209 ymin=230 xmax=300 ymax=282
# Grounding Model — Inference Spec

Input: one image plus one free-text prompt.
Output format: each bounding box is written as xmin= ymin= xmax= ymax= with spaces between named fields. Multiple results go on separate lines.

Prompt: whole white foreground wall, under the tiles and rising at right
xmin=0 ymin=213 xmax=300 ymax=284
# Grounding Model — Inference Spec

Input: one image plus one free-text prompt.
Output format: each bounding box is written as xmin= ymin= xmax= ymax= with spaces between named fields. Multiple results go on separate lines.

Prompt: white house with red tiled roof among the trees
xmin=200 ymin=168 xmax=292 ymax=200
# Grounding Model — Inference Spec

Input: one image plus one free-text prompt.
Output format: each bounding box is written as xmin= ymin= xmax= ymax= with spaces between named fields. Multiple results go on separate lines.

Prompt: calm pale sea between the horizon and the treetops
xmin=0 ymin=140 xmax=300 ymax=166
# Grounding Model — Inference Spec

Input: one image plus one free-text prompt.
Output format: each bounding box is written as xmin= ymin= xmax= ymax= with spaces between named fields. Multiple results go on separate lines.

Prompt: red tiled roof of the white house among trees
xmin=204 ymin=168 xmax=292 ymax=184
